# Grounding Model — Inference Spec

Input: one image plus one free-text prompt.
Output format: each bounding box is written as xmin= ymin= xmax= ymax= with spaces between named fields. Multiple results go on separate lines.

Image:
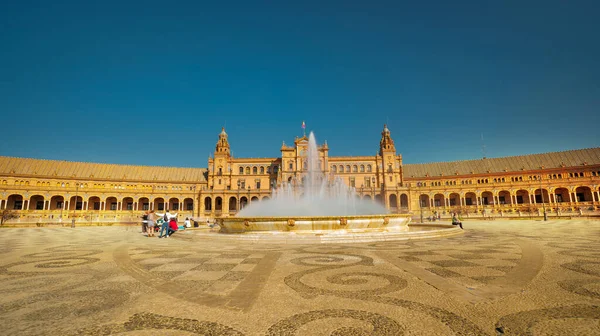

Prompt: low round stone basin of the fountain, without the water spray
xmin=219 ymin=214 xmax=410 ymax=235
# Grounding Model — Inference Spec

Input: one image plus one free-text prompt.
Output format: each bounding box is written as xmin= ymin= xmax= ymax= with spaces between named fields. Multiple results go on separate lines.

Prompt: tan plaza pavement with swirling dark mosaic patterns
xmin=0 ymin=220 xmax=600 ymax=335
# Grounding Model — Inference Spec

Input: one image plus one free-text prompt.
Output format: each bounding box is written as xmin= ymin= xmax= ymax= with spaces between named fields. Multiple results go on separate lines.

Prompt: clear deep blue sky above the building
xmin=0 ymin=0 xmax=600 ymax=167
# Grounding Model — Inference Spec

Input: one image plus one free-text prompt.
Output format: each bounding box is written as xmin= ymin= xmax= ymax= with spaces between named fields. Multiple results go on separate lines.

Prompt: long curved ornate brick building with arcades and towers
xmin=0 ymin=126 xmax=600 ymax=223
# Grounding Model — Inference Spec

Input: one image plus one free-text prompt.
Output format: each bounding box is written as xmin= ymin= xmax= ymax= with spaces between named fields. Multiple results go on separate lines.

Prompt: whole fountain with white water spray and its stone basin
xmin=219 ymin=132 xmax=410 ymax=238
